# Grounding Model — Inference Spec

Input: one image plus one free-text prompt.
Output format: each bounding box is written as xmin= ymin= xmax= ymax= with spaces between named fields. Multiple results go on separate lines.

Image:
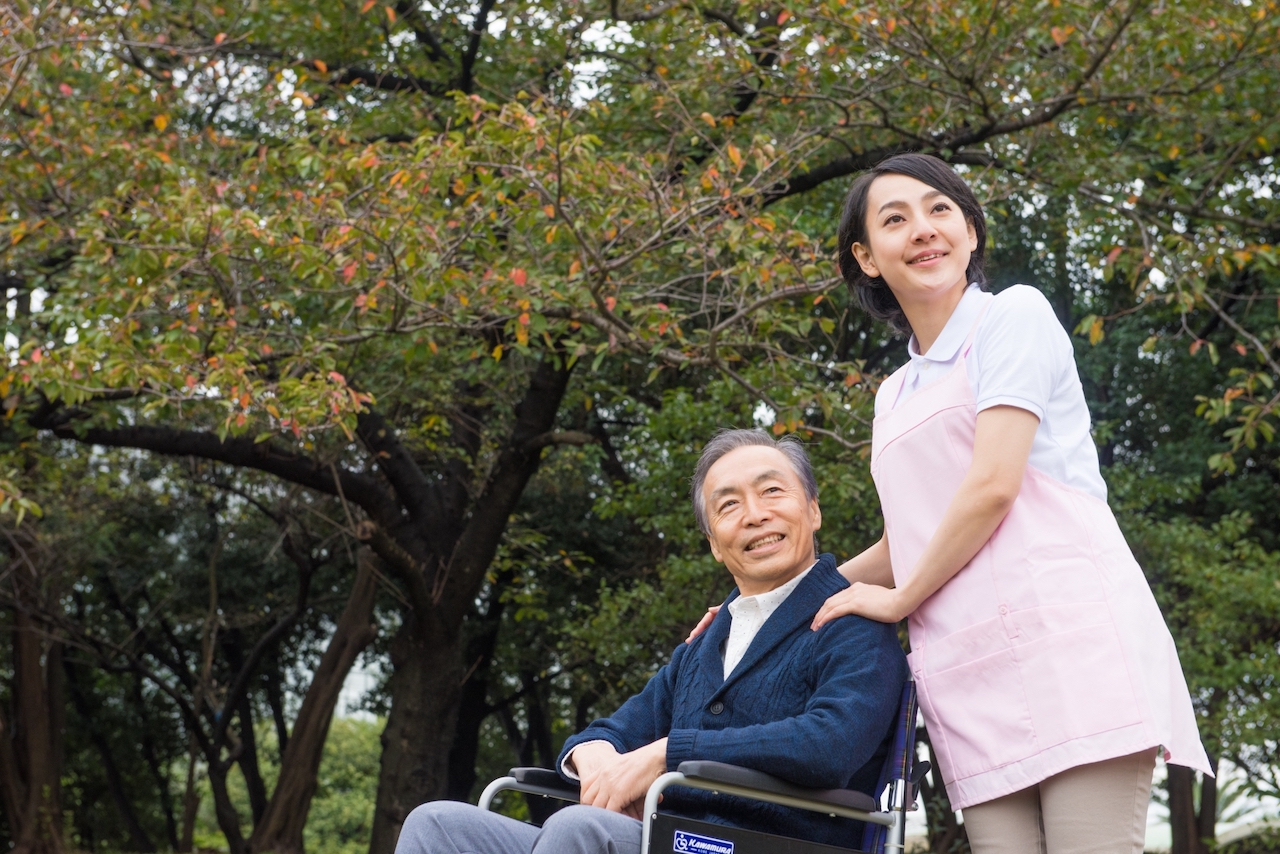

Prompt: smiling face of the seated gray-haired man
xmin=703 ymin=446 xmax=822 ymax=595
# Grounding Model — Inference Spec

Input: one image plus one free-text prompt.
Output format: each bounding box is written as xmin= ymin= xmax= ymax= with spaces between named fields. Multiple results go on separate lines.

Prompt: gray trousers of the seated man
xmin=396 ymin=800 xmax=640 ymax=854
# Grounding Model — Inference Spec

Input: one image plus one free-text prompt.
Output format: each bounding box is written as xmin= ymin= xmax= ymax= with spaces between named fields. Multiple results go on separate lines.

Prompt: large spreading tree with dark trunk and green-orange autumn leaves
xmin=10 ymin=0 xmax=1277 ymax=851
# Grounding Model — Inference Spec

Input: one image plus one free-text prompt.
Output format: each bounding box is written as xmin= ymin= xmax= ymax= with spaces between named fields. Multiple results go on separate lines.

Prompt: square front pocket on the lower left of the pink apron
xmin=916 ymin=648 xmax=1038 ymax=780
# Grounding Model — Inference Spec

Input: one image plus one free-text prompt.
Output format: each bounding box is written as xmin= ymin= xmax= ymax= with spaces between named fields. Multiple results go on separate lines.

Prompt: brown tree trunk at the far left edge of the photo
xmin=0 ymin=606 xmax=64 ymax=854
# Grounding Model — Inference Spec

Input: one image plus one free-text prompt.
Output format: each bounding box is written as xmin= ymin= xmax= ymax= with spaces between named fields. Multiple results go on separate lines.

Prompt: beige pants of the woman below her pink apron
xmin=963 ymin=749 xmax=1156 ymax=854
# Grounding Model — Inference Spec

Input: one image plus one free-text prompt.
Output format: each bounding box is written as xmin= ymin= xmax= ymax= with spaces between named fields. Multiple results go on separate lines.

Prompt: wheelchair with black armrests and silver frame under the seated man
xmin=479 ymin=680 xmax=929 ymax=854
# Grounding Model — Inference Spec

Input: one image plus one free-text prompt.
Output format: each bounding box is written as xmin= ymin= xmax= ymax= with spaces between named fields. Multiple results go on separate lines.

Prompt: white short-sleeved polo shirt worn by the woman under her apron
xmin=876 ymin=284 xmax=1107 ymax=502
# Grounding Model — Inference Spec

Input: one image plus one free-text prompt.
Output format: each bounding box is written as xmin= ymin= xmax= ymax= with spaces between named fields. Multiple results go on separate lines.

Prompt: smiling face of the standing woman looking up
xmin=852 ymin=174 xmax=978 ymax=311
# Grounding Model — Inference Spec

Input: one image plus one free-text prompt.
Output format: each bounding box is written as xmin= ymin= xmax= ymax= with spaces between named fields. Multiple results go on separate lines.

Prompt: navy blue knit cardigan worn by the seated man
xmin=556 ymin=554 xmax=908 ymax=846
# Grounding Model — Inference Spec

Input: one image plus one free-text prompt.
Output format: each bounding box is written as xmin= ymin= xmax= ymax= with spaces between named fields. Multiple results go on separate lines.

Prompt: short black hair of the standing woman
xmin=836 ymin=154 xmax=987 ymax=335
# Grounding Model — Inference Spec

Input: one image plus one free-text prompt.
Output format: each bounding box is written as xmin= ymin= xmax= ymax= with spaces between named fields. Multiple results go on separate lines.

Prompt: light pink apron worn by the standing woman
xmin=872 ymin=315 xmax=1208 ymax=809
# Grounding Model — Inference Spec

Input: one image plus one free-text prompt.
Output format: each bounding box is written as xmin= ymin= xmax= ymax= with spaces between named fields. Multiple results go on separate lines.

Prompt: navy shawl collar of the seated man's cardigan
xmin=696 ymin=554 xmax=849 ymax=694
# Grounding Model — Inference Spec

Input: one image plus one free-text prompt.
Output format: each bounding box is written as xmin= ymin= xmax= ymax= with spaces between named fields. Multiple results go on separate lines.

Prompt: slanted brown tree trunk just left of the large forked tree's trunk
xmin=248 ymin=549 xmax=378 ymax=854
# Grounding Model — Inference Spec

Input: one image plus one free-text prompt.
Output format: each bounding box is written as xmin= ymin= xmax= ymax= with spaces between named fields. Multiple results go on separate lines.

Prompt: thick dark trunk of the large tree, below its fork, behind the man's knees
xmin=369 ymin=615 xmax=463 ymax=854
